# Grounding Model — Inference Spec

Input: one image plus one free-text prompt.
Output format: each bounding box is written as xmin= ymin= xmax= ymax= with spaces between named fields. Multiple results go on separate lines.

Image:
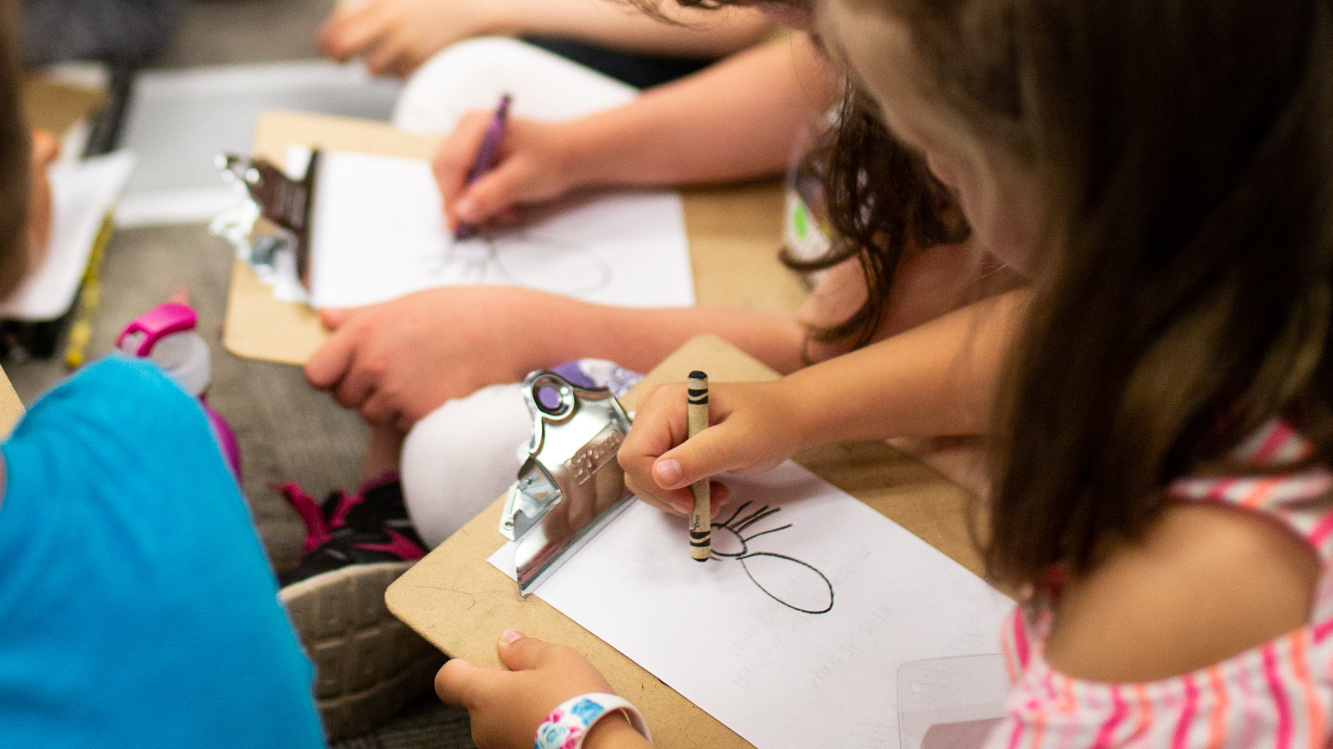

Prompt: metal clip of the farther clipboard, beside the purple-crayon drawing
xmin=209 ymin=148 xmax=320 ymax=293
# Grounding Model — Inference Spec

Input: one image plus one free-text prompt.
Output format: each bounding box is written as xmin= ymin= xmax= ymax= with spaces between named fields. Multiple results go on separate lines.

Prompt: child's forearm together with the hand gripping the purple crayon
xmin=435 ymin=35 xmax=838 ymax=227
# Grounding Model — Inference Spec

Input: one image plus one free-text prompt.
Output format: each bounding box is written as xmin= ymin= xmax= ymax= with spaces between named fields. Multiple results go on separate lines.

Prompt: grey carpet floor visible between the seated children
xmin=4 ymin=0 xmax=473 ymax=749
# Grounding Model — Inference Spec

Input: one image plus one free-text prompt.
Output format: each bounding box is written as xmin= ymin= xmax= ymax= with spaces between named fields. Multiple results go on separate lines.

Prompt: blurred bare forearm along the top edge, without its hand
xmin=491 ymin=0 xmax=772 ymax=57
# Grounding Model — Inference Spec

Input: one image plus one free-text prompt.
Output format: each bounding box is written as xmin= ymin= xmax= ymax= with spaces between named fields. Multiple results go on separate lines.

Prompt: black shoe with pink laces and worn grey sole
xmin=279 ymin=476 xmax=444 ymax=741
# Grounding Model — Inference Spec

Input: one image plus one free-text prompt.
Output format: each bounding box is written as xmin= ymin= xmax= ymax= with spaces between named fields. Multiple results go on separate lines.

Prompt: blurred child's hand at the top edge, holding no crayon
xmin=317 ymin=0 xmax=504 ymax=77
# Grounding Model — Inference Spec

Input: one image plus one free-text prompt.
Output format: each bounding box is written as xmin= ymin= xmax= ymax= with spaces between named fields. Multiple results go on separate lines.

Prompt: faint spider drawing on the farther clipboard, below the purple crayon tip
xmin=428 ymin=231 xmax=611 ymax=296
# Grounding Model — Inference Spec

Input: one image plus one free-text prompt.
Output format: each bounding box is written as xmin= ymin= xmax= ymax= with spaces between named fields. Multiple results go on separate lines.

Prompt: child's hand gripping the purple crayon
xmin=433 ymin=109 xmax=580 ymax=231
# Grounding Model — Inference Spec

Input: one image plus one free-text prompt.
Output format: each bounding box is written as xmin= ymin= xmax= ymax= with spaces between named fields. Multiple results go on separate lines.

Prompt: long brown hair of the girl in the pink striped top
xmin=837 ymin=0 xmax=1333 ymax=584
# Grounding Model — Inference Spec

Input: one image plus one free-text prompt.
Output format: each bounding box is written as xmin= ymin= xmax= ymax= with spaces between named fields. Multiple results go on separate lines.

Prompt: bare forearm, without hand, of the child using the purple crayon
xmin=559 ymin=35 xmax=838 ymax=185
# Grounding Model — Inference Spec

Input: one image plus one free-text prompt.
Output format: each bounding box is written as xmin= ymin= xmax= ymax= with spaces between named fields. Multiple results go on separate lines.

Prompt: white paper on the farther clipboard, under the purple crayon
xmin=303 ymin=151 xmax=694 ymax=308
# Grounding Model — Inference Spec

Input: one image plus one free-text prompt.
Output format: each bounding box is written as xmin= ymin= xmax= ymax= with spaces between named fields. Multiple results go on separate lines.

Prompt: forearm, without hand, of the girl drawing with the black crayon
xmin=781 ymin=289 xmax=1028 ymax=448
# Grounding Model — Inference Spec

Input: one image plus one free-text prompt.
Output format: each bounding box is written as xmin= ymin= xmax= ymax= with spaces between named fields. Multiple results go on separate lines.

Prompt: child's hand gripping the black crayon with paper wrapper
xmin=620 ymin=380 xmax=802 ymax=516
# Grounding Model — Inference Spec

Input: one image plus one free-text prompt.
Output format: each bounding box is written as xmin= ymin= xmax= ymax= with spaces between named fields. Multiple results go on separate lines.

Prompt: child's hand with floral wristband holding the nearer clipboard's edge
xmin=435 ymin=629 xmax=647 ymax=749
